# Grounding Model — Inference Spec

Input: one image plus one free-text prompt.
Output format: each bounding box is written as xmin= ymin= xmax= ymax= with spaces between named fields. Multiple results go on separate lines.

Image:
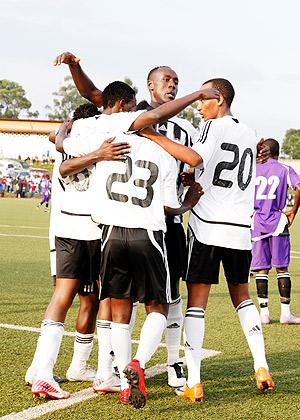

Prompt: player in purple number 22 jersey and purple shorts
xmin=251 ymin=139 xmax=300 ymax=324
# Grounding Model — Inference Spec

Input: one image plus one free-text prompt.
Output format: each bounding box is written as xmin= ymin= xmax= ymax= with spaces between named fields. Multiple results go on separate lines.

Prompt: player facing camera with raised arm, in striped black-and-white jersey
xmin=54 ymin=52 xmax=196 ymax=387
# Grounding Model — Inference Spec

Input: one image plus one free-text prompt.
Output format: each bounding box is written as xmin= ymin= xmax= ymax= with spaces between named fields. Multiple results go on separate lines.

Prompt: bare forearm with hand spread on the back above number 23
xmin=59 ymin=137 xmax=130 ymax=178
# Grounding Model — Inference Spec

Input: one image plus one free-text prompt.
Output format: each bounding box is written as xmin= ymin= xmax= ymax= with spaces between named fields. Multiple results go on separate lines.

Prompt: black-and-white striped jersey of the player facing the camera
xmin=155 ymin=116 xmax=197 ymax=223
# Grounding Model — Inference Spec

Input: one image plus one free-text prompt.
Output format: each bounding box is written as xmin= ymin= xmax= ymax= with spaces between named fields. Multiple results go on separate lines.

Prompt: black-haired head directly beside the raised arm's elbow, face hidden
xmin=102 ymin=81 xmax=136 ymax=112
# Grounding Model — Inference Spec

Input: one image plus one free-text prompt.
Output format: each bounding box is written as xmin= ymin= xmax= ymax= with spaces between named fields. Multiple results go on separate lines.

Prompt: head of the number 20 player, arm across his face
xmin=197 ymin=78 xmax=235 ymax=121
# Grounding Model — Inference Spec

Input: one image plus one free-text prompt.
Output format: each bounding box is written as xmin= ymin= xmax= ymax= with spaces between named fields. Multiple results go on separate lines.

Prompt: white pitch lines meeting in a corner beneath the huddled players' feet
xmin=0 ymin=324 xmax=221 ymax=420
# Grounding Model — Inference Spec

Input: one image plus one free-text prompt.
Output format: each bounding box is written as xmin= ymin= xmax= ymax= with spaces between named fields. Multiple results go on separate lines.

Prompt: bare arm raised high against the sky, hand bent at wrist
xmin=53 ymin=52 xmax=102 ymax=108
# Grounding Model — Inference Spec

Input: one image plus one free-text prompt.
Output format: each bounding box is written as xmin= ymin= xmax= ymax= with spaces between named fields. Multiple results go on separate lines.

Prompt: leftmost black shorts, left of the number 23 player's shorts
xmin=55 ymin=236 xmax=101 ymax=293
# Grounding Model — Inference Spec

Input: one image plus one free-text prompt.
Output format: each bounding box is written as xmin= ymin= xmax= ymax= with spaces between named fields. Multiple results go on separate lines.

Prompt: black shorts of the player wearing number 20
xmin=185 ymin=236 xmax=251 ymax=284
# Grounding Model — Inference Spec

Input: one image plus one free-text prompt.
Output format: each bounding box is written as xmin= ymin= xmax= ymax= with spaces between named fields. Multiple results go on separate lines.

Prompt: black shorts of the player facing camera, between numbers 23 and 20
xmin=165 ymin=223 xmax=187 ymax=301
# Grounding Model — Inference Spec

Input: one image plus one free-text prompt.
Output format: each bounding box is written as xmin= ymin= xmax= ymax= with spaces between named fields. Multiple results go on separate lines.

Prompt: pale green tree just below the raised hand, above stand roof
xmin=46 ymin=76 xmax=87 ymax=120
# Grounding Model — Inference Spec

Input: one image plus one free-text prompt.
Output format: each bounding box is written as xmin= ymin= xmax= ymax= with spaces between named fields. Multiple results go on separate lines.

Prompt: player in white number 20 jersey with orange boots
xmin=138 ymin=78 xmax=274 ymax=401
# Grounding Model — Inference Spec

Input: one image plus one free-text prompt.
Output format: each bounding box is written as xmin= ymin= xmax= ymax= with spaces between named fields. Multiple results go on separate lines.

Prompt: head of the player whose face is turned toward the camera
xmin=147 ymin=66 xmax=178 ymax=105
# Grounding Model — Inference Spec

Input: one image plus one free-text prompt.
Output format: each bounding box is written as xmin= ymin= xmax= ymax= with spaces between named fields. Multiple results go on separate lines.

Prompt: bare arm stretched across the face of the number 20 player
xmin=129 ymin=88 xmax=220 ymax=131
